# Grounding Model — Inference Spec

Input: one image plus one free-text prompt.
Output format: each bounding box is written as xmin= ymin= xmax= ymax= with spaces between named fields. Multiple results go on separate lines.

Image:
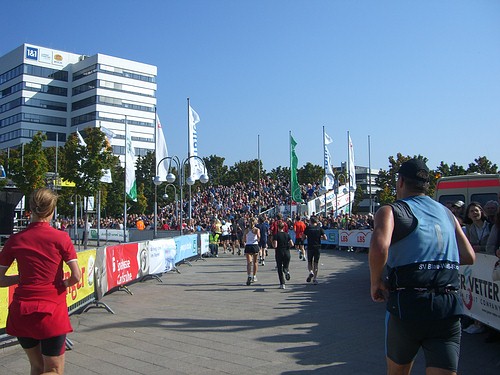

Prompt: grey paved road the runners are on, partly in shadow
xmin=0 ymin=250 xmax=500 ymax=375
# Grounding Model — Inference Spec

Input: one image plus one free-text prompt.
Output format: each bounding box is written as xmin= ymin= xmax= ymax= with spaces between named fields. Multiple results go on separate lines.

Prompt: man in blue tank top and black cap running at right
xmin=369 ymin=158 xmax=475 ymax=375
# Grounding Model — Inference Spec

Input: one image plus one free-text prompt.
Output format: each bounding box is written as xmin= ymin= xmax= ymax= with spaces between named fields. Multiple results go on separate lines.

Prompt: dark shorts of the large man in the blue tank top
xmin=386 ymin=312 xmax=461 ymax=372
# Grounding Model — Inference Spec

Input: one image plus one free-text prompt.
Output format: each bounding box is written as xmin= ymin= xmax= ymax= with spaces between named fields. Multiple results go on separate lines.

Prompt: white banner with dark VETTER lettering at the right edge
xmin=459 ymin=253 xmax=500 ymax=330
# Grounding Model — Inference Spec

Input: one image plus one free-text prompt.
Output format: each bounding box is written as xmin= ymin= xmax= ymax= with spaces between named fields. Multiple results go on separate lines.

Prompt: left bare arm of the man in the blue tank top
xmin=368 ymin=206 xmax=394 ymax=302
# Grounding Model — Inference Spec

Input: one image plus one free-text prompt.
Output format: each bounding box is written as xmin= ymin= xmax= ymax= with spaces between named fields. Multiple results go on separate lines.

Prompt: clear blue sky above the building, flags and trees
xmin=0 ymin=0 xmax=500 ymax=171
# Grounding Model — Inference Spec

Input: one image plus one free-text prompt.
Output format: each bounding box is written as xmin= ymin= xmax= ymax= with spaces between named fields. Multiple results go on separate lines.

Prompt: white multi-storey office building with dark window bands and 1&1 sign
xmin=0 ymin=44 xmax=157 ymax=161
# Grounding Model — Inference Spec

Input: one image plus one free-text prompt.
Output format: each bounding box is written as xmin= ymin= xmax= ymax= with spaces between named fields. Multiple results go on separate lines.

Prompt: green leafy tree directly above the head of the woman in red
xmin=9 ymin=132 xmax=49 ymax=196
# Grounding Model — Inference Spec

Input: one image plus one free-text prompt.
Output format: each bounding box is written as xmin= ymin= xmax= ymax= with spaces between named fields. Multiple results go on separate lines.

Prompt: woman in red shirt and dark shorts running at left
xmin=0 ymin=188 xmax=81 ymax=375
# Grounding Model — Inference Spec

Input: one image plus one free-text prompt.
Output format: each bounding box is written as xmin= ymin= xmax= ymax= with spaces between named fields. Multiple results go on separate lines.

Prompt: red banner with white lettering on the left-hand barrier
xmin=106 ymin=243 xmax=139 ymax=290
